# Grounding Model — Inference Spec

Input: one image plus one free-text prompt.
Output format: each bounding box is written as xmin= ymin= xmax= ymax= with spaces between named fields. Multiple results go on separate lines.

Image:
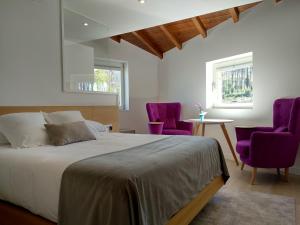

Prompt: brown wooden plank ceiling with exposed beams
xmin=111 ymin=0 xmax=280 ymax=59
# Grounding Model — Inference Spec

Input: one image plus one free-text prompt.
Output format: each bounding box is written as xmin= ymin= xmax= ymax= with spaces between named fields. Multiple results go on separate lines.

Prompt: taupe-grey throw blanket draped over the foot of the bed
xmin=58 ymin=136 xmax=229 ymax=225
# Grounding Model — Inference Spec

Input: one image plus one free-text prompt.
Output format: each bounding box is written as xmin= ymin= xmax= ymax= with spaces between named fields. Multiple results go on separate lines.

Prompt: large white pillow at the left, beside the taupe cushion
xmin=0 ymin=113 xmax=48 ymax=148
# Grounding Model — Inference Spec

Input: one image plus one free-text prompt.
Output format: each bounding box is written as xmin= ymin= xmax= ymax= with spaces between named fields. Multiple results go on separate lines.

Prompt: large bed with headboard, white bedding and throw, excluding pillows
xmin=0 ymin=106 xmax=228 ymax=225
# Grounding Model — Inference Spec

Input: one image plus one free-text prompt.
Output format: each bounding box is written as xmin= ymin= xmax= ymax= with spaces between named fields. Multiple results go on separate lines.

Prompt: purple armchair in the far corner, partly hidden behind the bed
xmin=146 ymin=102 xmax=193 ymax=135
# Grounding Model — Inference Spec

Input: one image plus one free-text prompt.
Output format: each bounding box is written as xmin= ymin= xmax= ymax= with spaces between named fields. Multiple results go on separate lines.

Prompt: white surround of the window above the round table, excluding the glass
xmin=206 ymin=52 xmax=254 ymax=109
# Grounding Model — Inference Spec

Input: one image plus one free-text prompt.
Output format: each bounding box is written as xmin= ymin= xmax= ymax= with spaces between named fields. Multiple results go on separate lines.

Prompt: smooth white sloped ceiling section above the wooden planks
xmin=62 ymin=0 xmax=259 ymax=39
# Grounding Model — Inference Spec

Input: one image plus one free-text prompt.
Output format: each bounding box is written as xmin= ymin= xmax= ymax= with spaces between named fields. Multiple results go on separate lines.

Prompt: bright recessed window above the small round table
xmin=206 ymin=52 xmax=253 ymax=108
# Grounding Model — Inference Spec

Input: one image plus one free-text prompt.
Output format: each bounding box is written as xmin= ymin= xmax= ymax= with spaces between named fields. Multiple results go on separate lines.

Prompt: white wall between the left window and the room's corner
xmin=85 ymin=39 xmax=159 ymax=133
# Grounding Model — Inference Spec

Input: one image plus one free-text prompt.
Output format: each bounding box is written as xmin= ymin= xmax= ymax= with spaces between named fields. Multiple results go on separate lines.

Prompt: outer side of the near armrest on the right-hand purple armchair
xmin=249 ymin=131 xmax=299 ymax=168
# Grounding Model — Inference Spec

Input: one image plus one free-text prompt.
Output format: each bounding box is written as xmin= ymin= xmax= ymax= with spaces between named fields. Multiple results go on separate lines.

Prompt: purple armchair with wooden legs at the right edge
xmin=236 ymin=98 xmax=300 ymax=184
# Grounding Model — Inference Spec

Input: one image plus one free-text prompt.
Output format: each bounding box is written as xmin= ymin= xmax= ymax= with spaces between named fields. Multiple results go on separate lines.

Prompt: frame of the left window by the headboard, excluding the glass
xmin=94 ymin=59 xmax=129 ymax=111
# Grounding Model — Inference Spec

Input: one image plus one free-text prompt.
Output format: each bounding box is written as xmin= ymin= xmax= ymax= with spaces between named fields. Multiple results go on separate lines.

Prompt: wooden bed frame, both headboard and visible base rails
xmin=0 ymin=106 xmax=224 ymax=225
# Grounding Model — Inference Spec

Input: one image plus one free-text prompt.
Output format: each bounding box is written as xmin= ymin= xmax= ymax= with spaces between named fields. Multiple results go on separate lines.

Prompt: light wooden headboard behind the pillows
xmin=0 ymin=106 xmax=119 ymax=132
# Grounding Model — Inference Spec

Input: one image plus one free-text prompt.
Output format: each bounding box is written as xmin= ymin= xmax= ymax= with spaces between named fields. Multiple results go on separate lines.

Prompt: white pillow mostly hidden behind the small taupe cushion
xmin=43 ymin=111 xmax=85 ymax=124
